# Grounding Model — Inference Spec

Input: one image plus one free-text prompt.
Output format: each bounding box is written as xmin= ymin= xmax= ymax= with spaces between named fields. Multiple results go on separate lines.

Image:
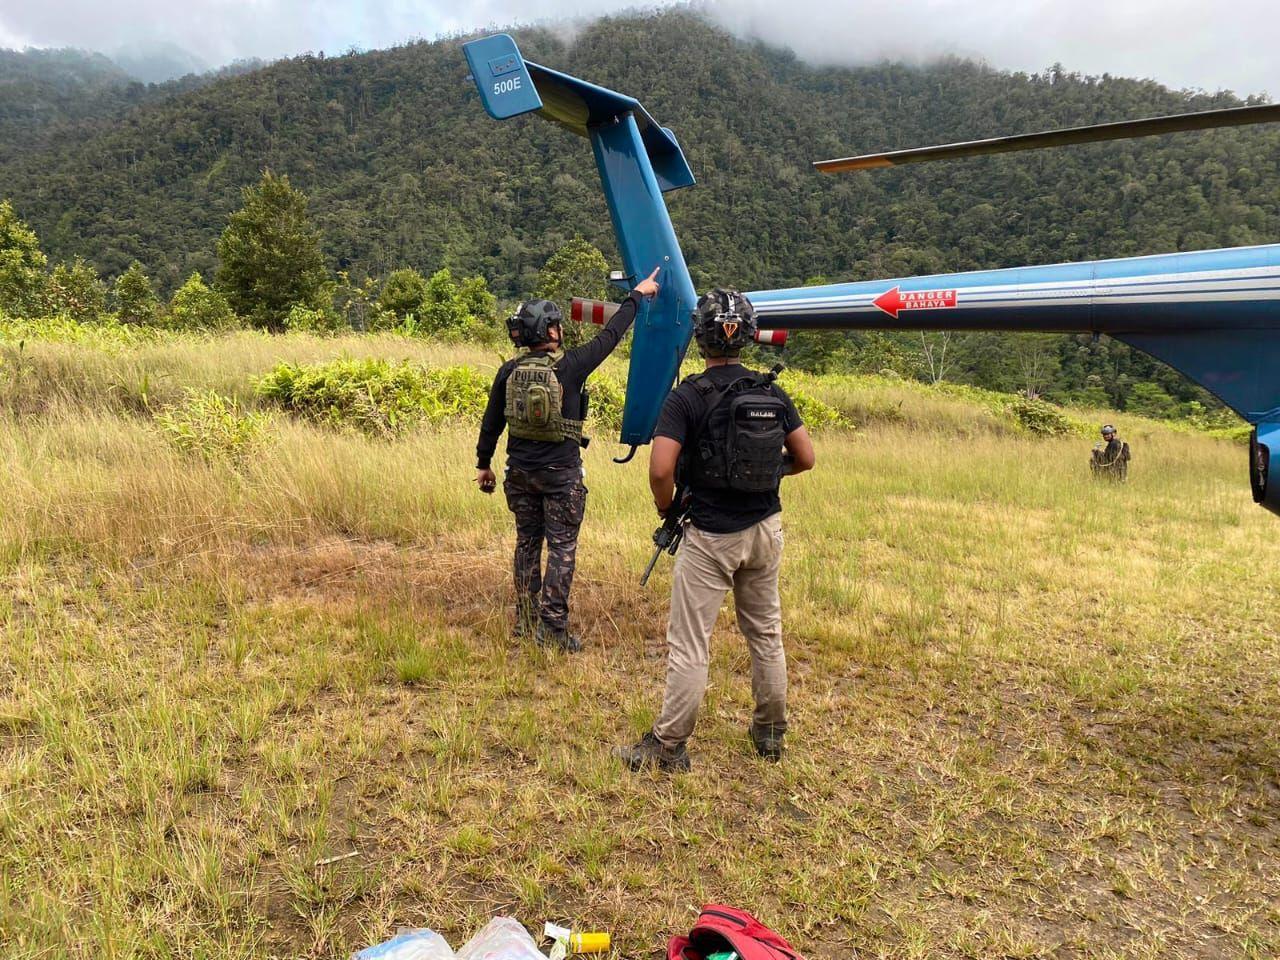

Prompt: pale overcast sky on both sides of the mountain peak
xmin=0 ymin=0 xmax=1280 ymax=96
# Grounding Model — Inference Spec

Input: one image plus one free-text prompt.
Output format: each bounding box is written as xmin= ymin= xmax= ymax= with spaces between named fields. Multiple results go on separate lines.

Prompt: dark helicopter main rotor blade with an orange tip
xmin=813 ymin=104 xmax=1280 ymax=173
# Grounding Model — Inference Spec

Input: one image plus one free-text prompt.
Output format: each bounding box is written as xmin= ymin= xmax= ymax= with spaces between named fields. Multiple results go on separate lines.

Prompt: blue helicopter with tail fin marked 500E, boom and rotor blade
xmin=462 ymin=33 xmax=1280 ymax=513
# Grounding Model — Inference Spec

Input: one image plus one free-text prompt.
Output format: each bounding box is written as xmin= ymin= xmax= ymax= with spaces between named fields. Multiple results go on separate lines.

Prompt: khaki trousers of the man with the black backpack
xmin=653 ymin=513 xmax=787 ymax=748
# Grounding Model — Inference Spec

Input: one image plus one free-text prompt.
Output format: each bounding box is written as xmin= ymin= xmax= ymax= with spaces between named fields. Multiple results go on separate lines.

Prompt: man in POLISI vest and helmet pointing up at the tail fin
xmin=476 ymin=269 xmax=658 ymax=653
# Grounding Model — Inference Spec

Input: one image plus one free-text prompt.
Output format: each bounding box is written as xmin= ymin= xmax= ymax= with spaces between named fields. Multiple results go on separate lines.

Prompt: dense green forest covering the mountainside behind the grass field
xmin=0 ymin=9 xmax=1280 ymax=416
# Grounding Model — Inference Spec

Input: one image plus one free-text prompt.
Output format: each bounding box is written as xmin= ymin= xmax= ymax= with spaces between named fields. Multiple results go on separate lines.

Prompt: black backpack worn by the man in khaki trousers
xmin=677 ymin=366 xmax=787 ymax=493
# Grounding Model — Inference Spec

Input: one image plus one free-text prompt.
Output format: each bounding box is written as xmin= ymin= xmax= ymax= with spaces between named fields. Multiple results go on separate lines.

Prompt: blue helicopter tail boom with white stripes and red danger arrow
xmin=748 ymin=244 xmax=1280 ymax=513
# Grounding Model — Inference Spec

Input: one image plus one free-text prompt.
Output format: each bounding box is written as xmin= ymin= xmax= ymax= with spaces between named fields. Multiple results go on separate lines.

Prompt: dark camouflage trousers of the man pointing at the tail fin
xmin=503 ymin=466 xmax=586 ymax=630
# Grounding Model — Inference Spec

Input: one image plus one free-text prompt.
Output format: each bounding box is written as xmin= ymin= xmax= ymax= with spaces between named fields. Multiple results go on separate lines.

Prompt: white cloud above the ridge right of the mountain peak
xmin=705 ymin=0 xmax=1280 ymax=93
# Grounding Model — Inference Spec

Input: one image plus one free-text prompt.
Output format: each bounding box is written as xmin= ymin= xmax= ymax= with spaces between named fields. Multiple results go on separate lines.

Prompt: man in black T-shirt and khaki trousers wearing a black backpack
xmin=616 ymin=289 xmax=814 ymax=771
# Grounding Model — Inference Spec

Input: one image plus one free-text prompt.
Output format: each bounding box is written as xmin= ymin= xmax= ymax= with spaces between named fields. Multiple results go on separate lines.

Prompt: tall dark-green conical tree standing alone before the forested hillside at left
xmin=216 ymin=170 xmax=332 ymax=330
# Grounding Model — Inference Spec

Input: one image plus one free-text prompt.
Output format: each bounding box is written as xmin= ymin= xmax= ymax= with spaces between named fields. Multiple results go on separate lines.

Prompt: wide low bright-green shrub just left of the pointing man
xmin=255 ymin=357 xmax=489 ymax=436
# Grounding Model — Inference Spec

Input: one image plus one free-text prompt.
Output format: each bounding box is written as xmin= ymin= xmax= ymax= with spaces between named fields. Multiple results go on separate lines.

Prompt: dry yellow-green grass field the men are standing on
xmin=0 ymin=334 xmax=1280 ymax=960
